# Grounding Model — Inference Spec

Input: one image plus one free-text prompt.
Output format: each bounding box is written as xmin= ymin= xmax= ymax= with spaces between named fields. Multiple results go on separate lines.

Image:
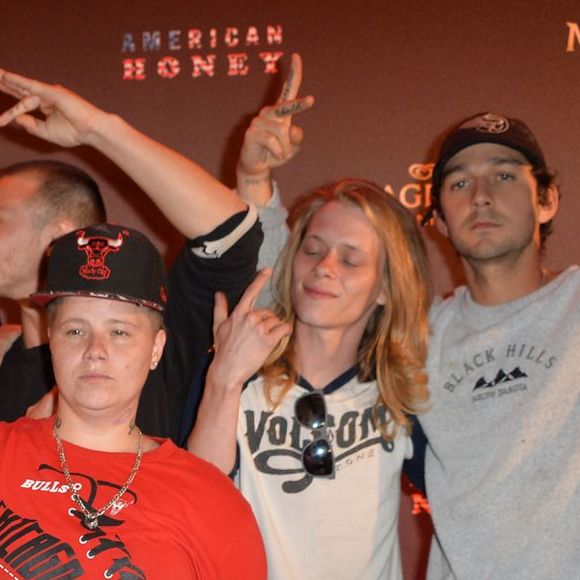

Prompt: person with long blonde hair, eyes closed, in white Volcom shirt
xmin=188 ymin=179 xmax=429 ymax=580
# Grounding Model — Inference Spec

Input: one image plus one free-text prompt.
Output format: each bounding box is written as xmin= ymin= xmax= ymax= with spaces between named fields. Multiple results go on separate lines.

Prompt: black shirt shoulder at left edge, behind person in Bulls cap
xmin=0 ymin=336 xmax=54 ymax=421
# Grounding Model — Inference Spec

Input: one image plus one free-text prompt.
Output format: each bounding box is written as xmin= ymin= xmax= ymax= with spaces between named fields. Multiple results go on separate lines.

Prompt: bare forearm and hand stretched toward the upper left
xmin=0 ymin=69 xmax=246 ymax=238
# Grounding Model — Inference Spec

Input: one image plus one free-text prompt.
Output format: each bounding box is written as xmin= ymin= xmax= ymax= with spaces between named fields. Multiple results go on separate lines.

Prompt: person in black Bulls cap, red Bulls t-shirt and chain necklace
xmin=0 ymin=224 xmax=266 ymax=580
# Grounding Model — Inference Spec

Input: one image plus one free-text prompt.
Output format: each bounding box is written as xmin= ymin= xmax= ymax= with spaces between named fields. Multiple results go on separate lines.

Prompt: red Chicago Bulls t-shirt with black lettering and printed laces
xmin=0 ymin=419 xmax=266 ymax=580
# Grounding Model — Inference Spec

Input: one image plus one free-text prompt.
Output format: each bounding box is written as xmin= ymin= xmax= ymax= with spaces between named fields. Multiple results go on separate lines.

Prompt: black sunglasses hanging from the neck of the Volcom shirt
xmin=294 ymin=392 xmax=334 ymax=477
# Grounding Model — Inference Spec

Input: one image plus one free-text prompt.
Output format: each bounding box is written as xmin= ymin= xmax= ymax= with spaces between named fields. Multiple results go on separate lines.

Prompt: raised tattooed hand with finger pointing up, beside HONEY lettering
xmin=236 ymin=54 xmax=314 ymax=206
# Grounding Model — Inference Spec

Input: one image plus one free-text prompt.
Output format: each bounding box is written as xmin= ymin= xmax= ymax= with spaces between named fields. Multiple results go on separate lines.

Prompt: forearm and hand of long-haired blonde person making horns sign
xmin=187 ymin=271 xmax=292 ymax=474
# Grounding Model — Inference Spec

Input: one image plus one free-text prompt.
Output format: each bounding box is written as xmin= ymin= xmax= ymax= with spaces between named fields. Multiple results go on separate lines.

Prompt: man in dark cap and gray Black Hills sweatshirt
xmin=420 ymin=113 xmax=580 ymax=580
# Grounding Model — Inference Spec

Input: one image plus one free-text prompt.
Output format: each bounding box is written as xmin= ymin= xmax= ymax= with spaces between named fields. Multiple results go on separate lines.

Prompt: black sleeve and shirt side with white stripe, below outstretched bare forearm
xmin=138 ymin=211 xmax=262 ymax=442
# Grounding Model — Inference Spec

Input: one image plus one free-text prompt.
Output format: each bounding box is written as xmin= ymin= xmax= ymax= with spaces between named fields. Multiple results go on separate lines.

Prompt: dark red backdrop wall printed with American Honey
xmin=0 ymin=0 xmax=580 ymax=578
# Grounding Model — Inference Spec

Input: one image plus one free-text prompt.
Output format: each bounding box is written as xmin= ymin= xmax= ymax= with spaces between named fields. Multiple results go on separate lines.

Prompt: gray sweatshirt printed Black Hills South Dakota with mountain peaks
xmin=421 ymin=266 xmax=580 ymax=580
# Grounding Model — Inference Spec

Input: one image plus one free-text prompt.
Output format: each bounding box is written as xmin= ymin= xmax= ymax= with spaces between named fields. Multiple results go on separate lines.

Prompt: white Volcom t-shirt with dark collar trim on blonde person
xmin=237 ymin=369 xmax=412 ymax=580
